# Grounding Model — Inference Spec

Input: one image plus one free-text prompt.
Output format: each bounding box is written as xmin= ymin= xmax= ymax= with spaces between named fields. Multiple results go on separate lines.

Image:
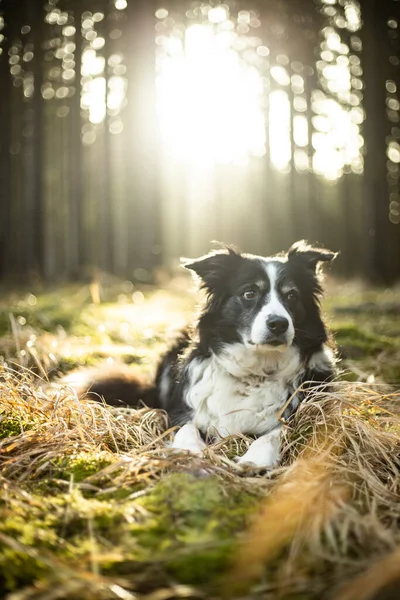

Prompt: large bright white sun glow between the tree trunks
xmin=156 ymin=5 xmax=266 ymax=165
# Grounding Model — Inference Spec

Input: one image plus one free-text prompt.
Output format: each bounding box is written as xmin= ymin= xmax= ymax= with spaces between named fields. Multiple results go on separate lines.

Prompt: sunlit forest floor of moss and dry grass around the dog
xmin=0 ymin=276 xmax=400 ymax=600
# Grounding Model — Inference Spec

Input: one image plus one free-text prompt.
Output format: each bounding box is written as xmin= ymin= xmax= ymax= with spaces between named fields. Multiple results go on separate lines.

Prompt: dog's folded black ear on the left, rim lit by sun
xmin=183 ymin=248 xmax=241 ymax=292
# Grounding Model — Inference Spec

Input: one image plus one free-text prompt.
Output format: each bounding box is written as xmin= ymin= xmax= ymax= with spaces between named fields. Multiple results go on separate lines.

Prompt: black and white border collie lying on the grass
xmin=79 ymin=241 xmax=336 ymax=468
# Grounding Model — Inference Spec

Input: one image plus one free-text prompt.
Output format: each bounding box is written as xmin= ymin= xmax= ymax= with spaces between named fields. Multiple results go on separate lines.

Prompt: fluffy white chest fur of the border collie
xmin=185 ymin=349 xmax=300 ymax=437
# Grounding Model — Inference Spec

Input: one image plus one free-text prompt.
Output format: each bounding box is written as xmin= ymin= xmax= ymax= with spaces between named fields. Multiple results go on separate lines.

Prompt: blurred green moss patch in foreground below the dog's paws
xmin=128 ymin=473 xmax=256 ymax=584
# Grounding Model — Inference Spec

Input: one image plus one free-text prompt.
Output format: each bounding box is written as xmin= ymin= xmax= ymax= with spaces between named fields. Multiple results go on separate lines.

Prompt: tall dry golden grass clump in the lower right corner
xmin=226 ymin=383 xmax=400 ymax=600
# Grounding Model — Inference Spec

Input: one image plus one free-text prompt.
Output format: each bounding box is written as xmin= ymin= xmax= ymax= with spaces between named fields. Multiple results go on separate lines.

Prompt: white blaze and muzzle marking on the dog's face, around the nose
xmin=250 ymin=262 xmax=294 ymax=351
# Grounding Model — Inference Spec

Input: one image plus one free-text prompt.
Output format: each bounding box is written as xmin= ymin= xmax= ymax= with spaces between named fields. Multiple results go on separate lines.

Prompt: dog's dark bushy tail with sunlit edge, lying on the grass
xmin=62 ymin=365 xmax=161 ymax=408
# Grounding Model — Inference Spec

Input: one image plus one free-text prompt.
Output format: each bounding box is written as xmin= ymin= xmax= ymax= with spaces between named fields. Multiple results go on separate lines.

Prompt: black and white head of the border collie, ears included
xmin=184 ymin=242 xmax=336 ymax=352
